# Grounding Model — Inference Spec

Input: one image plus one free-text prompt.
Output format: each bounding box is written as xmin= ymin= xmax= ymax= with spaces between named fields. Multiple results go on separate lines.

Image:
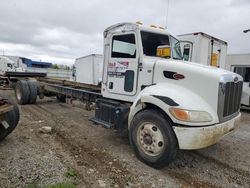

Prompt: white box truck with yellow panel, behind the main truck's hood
xmin=178 ymin=32 xmax=227 ymax=68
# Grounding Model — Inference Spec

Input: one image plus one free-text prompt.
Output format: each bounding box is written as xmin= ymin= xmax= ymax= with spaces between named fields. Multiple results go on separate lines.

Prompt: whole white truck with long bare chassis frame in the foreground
xmin=15 ymin=23 xmax=242 ymax=168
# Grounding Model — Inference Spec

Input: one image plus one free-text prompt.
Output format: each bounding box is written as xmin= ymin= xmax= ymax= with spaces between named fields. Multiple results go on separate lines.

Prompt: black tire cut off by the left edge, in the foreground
xmin=0 ymin=94 xmax=20 ymax=141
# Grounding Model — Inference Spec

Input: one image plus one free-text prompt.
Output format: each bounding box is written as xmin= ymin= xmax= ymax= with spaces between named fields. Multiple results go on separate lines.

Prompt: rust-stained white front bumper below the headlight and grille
xmin=173 ymin=113 xmax=241 ymax=150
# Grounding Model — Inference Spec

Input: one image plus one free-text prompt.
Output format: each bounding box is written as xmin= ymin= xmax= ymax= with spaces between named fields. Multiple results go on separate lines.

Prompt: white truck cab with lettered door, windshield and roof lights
xmin=102 ymin=23 xmax=182 ymax=102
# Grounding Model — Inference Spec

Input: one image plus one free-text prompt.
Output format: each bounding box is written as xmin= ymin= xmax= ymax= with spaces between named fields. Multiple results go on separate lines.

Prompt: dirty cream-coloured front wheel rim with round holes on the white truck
xmin=137 ymin=122 xmax=165 ymax=156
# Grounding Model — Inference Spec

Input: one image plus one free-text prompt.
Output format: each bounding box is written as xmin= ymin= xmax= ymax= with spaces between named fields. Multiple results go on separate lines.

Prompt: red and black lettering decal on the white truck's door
xmin=108 ymin=61 xmax=129 ymax=77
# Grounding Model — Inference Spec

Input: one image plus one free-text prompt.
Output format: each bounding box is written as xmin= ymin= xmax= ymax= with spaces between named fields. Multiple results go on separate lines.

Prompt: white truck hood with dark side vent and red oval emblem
xmin=149 ymin=58 xmax=242 ymax=114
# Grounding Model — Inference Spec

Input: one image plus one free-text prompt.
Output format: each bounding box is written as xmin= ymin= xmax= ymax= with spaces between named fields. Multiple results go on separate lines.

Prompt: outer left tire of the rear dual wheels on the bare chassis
xmin=15 ymin=80 xmax=30 ymax=105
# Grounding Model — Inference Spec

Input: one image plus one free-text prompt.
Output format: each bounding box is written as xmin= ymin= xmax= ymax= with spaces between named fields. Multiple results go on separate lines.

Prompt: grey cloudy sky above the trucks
xmin=0 ymin=0 xmax=250 ymax=65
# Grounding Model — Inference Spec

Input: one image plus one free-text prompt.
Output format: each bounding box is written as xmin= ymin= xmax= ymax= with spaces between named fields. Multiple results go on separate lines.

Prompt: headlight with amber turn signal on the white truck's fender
xmin=169 ymin=108 xmax=213 ymax=122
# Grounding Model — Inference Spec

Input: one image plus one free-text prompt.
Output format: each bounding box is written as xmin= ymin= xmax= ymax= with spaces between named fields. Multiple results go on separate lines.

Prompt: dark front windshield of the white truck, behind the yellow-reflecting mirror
xmin=141 ymin=31 xmax=182 ymax=60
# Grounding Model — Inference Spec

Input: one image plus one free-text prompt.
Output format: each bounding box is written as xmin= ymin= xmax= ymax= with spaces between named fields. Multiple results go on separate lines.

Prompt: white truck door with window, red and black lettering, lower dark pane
xmin=107 ymin=32 xmax=138 ymax=95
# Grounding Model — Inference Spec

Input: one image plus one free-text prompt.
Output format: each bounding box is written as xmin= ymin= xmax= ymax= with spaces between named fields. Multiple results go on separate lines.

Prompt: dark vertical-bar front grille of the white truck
xmin=218 ymin=81 xmax=243 ymax=121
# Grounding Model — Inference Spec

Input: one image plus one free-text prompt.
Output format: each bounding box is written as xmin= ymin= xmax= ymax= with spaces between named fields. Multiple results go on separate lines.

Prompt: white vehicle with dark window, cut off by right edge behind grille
xmin=225 ymin=54 xmax=250 ymax=107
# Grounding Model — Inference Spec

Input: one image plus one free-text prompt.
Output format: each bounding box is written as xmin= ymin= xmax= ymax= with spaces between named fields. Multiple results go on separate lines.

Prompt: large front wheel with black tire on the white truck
xmin=129 ymin=109 xmax=178 ymax=168
